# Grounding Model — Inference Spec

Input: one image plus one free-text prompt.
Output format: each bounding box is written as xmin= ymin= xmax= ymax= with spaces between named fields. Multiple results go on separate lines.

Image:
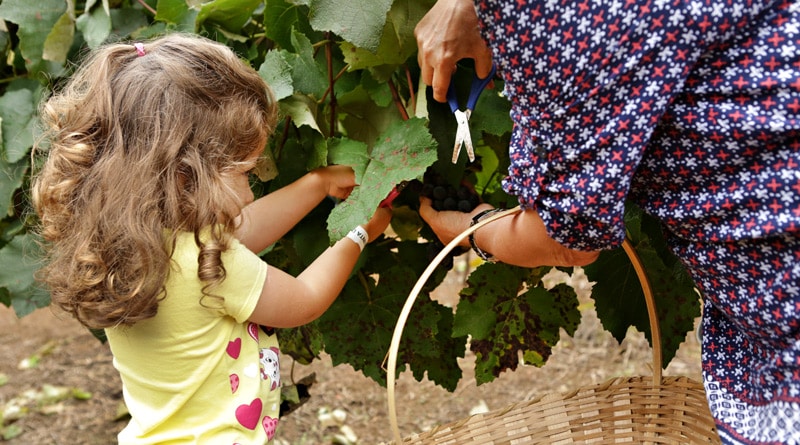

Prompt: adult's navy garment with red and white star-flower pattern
xmin=476 ymin=0 xmax=800 ymax=444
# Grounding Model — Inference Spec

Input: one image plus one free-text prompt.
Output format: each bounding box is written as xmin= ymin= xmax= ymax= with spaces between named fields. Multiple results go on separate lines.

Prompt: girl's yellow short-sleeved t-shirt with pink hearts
xmin=106 ymin=233 xmax=281 ymax=445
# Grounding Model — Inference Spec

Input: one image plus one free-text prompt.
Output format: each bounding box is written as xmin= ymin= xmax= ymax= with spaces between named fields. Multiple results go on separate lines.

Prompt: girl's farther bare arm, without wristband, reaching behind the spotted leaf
xmin=236 ymin=165 xmax=356 ymax=252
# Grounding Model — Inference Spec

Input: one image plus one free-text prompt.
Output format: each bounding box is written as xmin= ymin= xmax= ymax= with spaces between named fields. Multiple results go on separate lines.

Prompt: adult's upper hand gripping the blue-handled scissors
xmin=414 ymin=0 xmax=492 ymax=102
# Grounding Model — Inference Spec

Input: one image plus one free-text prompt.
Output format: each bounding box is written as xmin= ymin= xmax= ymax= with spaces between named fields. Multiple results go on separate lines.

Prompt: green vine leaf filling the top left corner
xmin=0 ymin=0 xmax=66 ymax=75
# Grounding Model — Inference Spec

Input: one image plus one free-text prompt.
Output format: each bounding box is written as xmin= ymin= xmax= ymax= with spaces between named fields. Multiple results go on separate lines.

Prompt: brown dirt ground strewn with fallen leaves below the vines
xmin=0 ymin=266 xmax=700 ymax=445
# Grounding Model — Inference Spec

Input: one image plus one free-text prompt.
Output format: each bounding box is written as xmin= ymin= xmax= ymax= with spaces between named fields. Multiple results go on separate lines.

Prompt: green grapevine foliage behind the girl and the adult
xmin=0 ymin=0 xmax=699 ymax=390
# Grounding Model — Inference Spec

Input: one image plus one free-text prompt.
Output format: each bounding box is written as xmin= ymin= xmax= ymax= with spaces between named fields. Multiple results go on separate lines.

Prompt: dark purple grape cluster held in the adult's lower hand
xmin=420 ymin=170 xmax=481 ymax=270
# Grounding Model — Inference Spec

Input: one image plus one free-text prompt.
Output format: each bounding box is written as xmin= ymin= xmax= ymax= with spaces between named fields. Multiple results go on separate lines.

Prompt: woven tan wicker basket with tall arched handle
xmin=386 ymin=207 xmax=720 ymax=445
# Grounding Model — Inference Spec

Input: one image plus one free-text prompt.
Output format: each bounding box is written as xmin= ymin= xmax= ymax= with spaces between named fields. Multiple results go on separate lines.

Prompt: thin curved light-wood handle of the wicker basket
xmin=386 ymin=206 xmax=661 ymax=445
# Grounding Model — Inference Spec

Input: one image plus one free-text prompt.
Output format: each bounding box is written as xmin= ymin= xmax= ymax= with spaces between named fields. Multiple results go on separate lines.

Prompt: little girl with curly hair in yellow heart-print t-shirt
xmin=32 ymin=34 xmax=391 ymax=444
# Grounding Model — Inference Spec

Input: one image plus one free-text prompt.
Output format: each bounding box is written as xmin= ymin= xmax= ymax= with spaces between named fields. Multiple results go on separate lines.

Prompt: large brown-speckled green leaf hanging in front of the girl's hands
xmin=328 ymin=118 xmax=436 ymax=242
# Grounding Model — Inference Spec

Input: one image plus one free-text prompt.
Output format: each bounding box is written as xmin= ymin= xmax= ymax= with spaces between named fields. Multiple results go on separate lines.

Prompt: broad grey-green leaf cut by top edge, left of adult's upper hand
xmin=309 ymin=0 xmax=392 ymax=52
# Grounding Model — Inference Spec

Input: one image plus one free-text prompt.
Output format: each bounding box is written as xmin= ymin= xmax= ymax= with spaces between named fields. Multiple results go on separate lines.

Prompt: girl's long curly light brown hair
xmin=32 ymin=34 xmax=277 ymax=328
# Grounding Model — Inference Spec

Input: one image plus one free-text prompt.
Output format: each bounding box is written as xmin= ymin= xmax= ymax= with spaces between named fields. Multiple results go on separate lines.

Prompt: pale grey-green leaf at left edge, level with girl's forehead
xmin=0 ymin=88 xmax=38 ymax=163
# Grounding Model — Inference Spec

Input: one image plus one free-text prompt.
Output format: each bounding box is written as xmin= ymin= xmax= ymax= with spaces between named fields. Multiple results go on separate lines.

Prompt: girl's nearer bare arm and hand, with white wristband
xmin=245 ymin=207 xmax=391 ymax=328
